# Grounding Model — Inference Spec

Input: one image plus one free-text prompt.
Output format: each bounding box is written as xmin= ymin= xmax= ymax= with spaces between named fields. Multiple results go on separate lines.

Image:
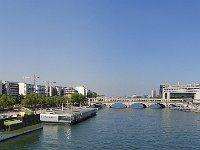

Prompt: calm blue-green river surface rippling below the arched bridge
xmin=0 ymin=108 xmax=200 ymax=150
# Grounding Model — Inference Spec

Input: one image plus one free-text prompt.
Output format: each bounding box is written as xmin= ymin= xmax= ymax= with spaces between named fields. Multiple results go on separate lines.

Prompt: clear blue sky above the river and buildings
xmin=0 ymin=0 xmax=200 ymax=96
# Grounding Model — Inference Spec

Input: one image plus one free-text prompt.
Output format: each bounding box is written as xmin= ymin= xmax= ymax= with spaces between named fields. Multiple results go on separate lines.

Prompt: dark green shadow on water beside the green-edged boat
xmin=0 ymin=130 xmax=42 ymax=150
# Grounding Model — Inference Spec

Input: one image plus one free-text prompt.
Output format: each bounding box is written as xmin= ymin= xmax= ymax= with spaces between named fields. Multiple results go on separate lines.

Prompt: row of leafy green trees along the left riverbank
xmin=0 ymin=91 xmax=97 ymax=109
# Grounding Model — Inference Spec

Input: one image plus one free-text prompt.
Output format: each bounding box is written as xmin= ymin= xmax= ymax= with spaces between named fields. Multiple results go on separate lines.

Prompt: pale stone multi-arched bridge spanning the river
xmin=88 ymin=97 xmax=184 ymax=107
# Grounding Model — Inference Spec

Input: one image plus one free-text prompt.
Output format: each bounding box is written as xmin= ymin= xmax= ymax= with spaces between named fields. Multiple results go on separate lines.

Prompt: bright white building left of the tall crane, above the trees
xmin=19 ymin=83 xmax=34 ymax=96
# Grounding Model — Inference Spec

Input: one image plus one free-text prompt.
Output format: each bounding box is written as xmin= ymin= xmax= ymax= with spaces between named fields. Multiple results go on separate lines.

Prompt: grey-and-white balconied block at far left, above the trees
xmin=2 ymin=81 xmax=19 ymax=96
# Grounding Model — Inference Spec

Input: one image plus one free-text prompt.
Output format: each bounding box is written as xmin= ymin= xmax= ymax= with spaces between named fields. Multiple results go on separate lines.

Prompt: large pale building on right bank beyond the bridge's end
xmin=160 ymin=84 xmax=200 ymax=99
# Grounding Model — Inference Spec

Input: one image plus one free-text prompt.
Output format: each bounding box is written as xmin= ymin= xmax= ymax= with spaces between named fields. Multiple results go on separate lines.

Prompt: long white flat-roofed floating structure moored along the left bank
xmin=40 ymin=107 xmax=97 ymax=125
